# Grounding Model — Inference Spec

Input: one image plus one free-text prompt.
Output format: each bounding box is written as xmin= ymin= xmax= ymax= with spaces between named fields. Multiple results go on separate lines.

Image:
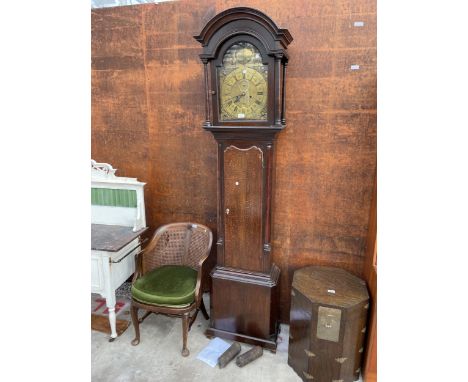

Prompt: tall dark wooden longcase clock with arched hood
xmin=195 ymin=7 xmax=292 ymax=351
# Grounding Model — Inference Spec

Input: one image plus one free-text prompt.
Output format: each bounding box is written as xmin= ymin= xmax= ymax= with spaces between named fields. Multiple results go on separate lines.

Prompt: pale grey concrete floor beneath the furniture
xmin=91 ymin=299 xmax=362 ymax=382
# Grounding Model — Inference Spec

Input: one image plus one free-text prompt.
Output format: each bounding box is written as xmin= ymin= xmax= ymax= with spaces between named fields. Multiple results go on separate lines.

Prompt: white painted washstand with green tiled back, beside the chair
xmin=91 ymin=160 xmax=146 ymax=340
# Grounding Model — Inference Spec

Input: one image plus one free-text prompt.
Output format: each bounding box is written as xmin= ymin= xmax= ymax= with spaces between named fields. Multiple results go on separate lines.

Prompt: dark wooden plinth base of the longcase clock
xmin=205 ymin=264 xmax=280 ymax=352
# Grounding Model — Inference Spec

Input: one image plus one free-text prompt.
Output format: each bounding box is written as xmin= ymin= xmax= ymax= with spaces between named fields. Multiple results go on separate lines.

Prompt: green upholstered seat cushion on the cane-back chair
xmin=132 ymin=265 xmax=197 ymax=306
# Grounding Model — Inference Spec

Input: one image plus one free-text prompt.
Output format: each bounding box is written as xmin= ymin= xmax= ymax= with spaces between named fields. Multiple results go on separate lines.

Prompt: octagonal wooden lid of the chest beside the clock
xmin=292 ymin=266 xmax=369 ymax=308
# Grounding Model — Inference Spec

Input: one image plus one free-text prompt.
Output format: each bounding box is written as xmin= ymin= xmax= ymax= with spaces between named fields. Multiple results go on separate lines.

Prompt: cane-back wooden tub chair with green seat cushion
xmin=131 ymin=223 xmax=213 ymax=357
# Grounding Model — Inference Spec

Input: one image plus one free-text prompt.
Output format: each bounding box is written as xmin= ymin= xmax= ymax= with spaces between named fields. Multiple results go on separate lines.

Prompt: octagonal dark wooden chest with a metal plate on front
xmin=288 ymin=266 xmax=369 ymax=382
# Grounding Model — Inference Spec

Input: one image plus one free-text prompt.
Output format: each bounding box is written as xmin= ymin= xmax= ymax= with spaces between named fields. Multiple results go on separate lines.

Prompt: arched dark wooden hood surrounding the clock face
xmin=194 ymin=7 xmax=293 ymax=134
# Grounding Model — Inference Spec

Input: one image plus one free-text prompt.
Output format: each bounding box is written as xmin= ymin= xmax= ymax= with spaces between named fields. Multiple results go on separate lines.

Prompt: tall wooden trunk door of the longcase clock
xmin=224 ymin=146 xmax=263 ymax=272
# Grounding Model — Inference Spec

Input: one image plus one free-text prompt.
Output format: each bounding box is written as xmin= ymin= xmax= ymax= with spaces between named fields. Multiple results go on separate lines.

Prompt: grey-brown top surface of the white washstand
xmin=91 ymin=224 xmax=148 ymax=252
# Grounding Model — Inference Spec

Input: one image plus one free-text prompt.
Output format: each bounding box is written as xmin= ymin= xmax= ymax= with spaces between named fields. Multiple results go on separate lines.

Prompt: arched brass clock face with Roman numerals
xmin=218 ymin=42 xmax=268 ymax=121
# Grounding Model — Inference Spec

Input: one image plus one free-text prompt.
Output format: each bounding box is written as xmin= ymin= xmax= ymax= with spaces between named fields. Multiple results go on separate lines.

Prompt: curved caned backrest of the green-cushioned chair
xmin=142 ymin=223 xmax=213 ymax=274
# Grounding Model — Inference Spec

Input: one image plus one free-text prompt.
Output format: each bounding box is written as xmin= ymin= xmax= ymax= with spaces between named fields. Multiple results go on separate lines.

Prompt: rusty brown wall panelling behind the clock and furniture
xmin=92 ymin=0 xmax=376 ymax=321
